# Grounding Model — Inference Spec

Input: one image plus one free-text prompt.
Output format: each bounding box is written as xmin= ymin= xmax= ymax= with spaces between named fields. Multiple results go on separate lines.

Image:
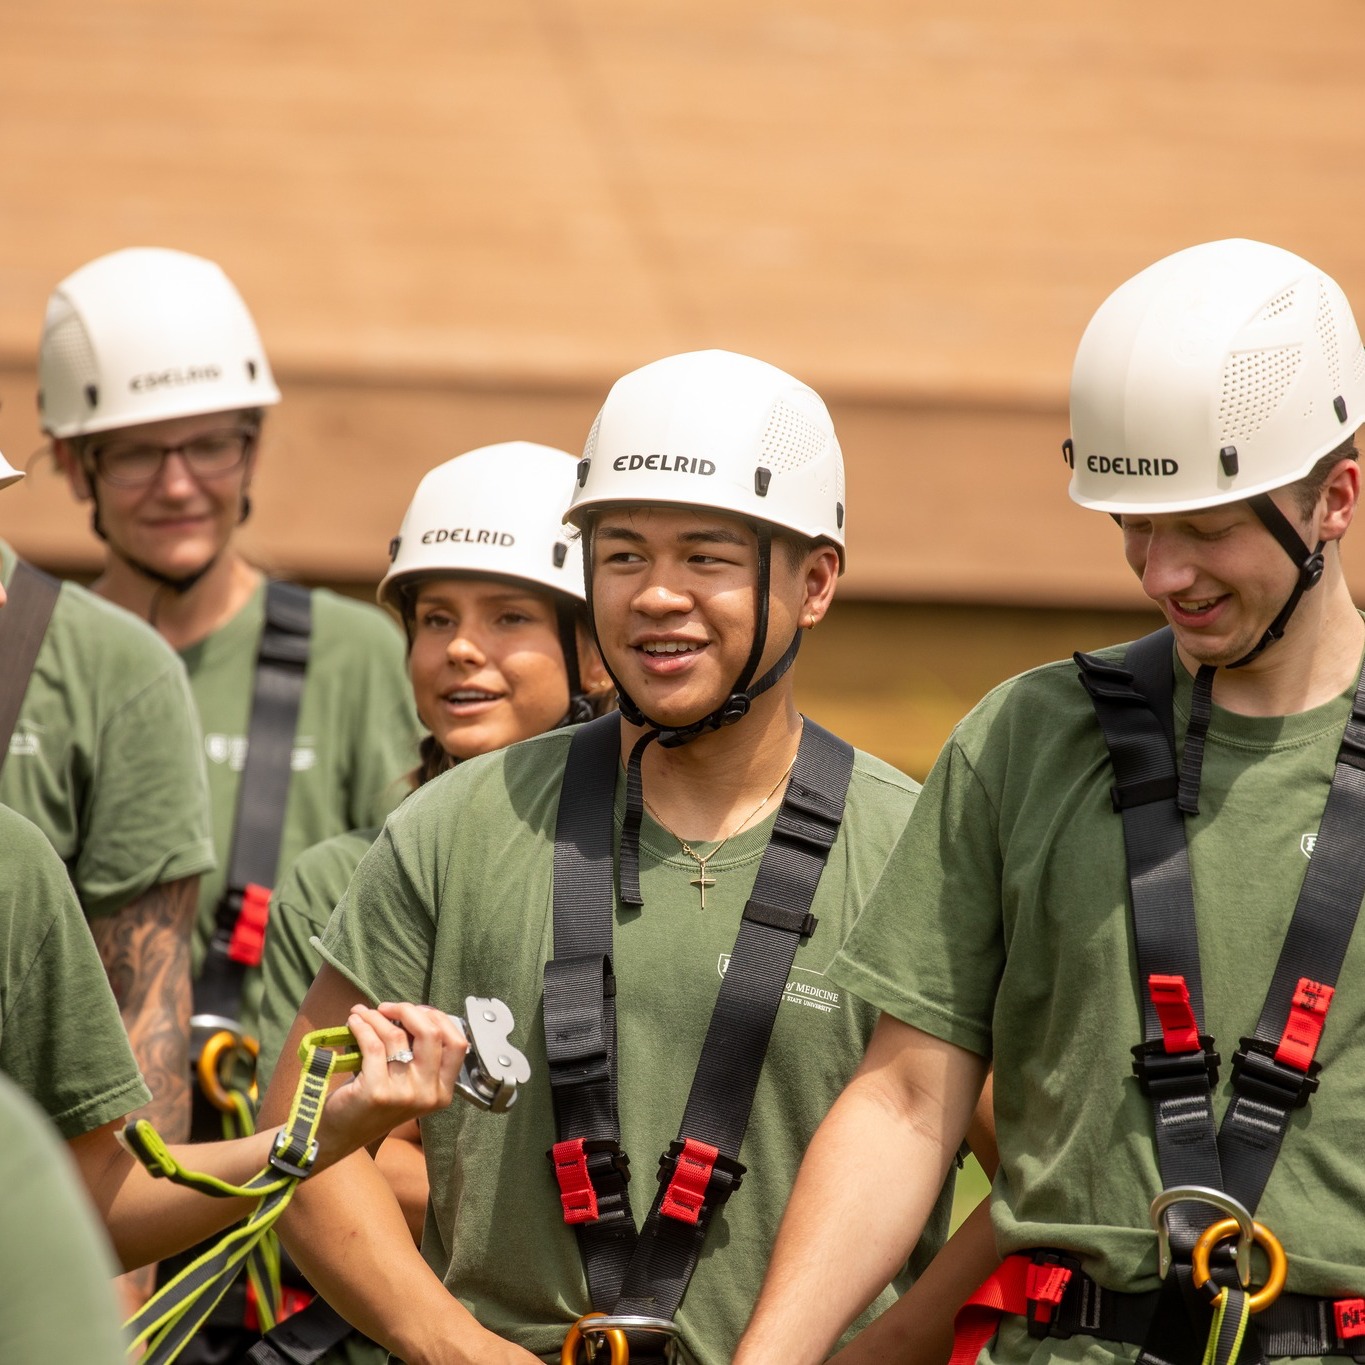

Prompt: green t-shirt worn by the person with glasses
xmin=180 ymin=583 xmax=418 ymax=1026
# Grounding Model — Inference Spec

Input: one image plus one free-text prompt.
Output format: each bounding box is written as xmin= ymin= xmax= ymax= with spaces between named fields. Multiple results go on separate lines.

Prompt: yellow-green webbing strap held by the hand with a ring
xmin=123 ymin=1028 xmax=360 ymax=1365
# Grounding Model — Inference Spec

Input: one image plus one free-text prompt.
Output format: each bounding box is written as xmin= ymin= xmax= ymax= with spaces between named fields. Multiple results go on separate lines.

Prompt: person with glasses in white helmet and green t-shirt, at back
xmin=38 ymin=248 xmax=418 ymax=1354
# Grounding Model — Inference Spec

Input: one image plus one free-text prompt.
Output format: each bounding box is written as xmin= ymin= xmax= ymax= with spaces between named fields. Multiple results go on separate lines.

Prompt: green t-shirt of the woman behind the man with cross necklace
xmin=257 ymin=829 xmax=379 ymax=1093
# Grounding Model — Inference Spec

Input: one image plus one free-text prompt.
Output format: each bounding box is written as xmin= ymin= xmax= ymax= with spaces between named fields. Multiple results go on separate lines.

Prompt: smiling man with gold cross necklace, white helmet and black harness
xmin=257 ymin=351 xmax=982 ymax=1365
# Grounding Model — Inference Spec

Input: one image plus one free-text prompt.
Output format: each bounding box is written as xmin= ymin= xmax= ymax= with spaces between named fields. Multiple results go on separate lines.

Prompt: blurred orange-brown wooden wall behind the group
xmin=0 ymin=0 xmax=1365 ymax=606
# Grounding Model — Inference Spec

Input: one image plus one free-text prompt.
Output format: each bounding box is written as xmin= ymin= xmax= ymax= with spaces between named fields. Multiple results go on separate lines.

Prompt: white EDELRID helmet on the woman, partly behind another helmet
xmin=378 ymin=441 xmax=583 ymax=616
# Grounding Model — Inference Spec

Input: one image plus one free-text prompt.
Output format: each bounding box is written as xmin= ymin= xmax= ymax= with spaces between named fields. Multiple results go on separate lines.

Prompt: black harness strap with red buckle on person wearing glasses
xmin=195 ymin=580 xmax=313 ymax=1020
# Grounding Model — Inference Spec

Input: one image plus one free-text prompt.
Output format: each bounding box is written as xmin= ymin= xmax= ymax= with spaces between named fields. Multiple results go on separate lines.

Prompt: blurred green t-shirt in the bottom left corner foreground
xmin=0 ymin=1076 xmax=126 ymax=1365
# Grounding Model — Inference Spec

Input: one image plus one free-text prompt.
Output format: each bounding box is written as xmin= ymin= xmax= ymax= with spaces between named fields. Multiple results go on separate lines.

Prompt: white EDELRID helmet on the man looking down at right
xmin=1063 ymin=239 xmax=1365 ymax=515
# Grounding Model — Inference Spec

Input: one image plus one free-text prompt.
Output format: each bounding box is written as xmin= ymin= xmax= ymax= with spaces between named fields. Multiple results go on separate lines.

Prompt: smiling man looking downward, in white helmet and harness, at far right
xmin=737 ymin=242 xmax=1365 ymax=1365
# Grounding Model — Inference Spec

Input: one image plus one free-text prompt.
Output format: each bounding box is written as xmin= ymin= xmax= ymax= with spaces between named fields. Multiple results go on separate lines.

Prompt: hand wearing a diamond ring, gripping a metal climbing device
xmin=314 ymin=1005 xmax=468 ymax=1170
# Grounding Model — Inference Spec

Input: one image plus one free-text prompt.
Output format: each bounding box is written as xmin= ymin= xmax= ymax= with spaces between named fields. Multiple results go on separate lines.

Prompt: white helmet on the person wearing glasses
xmin=38 ymin=247 xmax=280 ymax=437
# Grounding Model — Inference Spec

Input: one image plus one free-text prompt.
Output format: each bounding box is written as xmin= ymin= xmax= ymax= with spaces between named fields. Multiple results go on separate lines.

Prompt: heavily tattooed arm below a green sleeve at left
xmin=90 ymin=876 xmax=199 ymax=1143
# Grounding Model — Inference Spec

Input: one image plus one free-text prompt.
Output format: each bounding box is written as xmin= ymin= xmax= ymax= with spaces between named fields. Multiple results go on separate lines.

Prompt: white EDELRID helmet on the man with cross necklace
xmin=568 ymin=351 xmax=844 ymax=569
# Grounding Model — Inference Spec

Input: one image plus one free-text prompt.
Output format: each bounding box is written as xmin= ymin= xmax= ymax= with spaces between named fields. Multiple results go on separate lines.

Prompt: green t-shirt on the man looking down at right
xmin=831 ymin=651 xmax=1365 ymax=1361
